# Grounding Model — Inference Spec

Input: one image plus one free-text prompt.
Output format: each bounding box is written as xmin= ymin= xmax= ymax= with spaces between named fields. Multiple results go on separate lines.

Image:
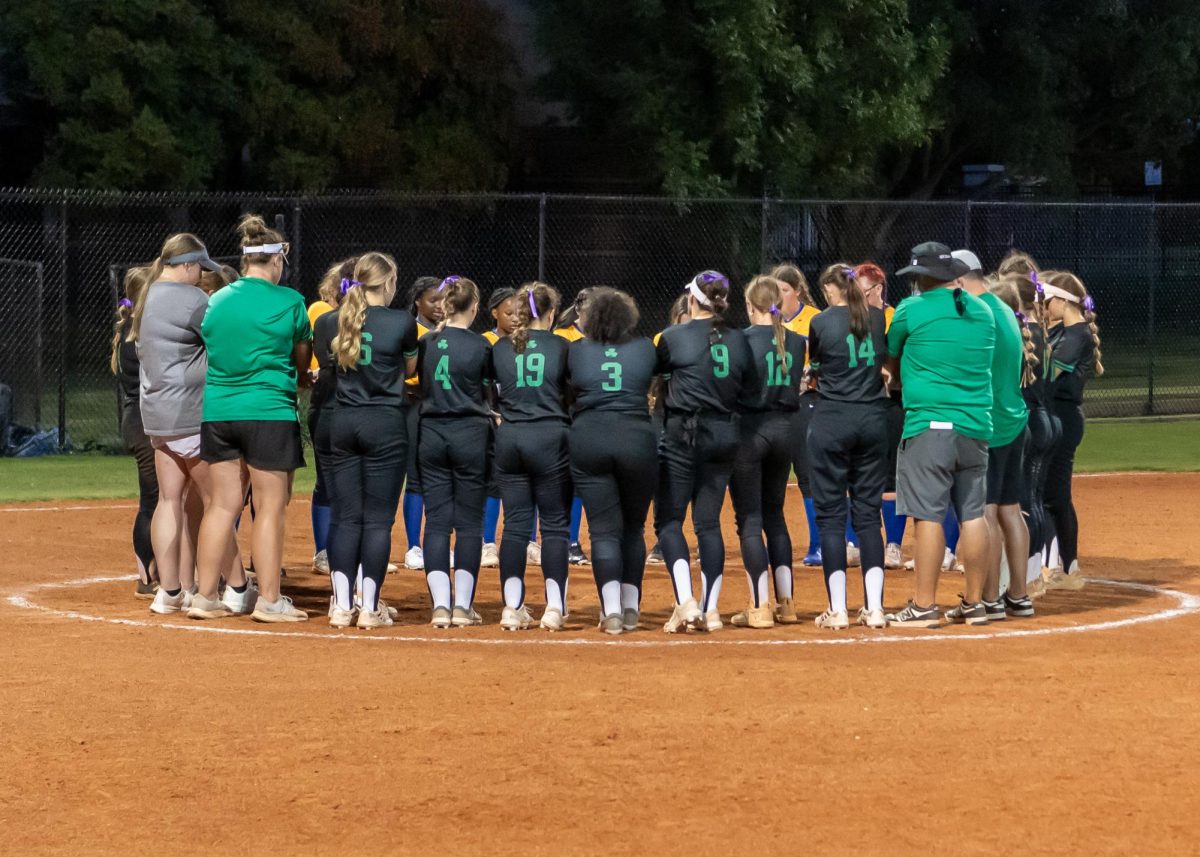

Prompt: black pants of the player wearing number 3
xmin=570 ymin=410 xmax=659 ymax=603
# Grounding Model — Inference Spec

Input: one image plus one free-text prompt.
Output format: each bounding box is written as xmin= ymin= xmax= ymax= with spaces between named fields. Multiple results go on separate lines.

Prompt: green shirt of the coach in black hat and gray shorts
xmin=888 ymin=287 xmax=996 ymax=441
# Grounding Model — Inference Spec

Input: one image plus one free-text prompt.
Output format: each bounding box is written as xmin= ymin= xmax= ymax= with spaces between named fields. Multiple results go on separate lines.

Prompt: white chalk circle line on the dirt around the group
xmin=6 ymin=575 xmax=1200 ymax=648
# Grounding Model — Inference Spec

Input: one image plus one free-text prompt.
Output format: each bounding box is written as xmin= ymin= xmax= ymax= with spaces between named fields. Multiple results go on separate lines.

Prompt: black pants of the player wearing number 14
xmin=809 ymin=400 xmax=888 ymax=579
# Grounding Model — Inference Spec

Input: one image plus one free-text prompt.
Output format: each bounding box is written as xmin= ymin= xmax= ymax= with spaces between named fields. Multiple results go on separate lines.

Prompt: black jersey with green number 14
xmin=809 ymin=306 xmax=888 ymax=402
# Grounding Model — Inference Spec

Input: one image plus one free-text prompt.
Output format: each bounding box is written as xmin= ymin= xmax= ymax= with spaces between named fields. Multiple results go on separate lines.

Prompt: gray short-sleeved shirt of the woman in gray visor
xmin=138 ymin=280 xmax=209 ymax=437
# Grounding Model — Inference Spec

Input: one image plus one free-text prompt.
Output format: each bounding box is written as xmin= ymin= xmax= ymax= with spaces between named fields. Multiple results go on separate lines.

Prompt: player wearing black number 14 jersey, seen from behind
xmin=808 ymin=264 xmax=888 ymax=630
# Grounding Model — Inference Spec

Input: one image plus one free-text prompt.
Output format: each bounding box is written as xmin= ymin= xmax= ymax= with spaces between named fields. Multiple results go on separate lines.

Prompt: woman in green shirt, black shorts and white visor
xmin=196 ymin=215 xmax=312 ymax=622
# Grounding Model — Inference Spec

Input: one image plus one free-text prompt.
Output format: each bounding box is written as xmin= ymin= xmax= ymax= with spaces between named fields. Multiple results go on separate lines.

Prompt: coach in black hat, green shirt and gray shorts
xmin=888 ymin=242 xmax=996 ymax=628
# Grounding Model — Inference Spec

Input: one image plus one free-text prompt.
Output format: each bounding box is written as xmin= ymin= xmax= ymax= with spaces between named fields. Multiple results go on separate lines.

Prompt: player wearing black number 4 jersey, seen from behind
xmin=416 ymin=276 xmax=492 ymax=628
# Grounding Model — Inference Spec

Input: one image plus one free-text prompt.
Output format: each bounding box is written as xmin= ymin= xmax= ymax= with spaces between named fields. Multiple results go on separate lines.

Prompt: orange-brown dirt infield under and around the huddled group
xmin=0 ymin=474 xmax=1200 ymax=857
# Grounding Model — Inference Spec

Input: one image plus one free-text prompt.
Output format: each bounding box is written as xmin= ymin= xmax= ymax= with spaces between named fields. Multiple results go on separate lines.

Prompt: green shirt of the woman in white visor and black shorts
xmin=200 ymin=277 xmax=312 ymax=422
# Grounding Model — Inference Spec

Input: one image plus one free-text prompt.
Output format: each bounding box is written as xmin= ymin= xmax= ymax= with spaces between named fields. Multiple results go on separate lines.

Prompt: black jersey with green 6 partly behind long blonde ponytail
xmin=313 ymin=306 xmax=416 ymax=408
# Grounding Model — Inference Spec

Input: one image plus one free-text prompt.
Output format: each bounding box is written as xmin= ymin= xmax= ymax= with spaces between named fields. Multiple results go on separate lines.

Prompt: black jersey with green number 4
xmin=416 ymin=328 xmax=492 ymax=417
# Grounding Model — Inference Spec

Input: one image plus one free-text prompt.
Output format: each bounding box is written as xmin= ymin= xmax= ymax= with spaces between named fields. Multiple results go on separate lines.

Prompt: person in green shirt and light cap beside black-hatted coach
xmin=953 ymin=250 xmax=1033 ymax=619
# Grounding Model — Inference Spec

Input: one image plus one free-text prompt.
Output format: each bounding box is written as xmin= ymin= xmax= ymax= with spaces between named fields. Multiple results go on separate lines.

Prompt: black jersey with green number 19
xmin=491 ymin=330 xmax=568 ymax=422
